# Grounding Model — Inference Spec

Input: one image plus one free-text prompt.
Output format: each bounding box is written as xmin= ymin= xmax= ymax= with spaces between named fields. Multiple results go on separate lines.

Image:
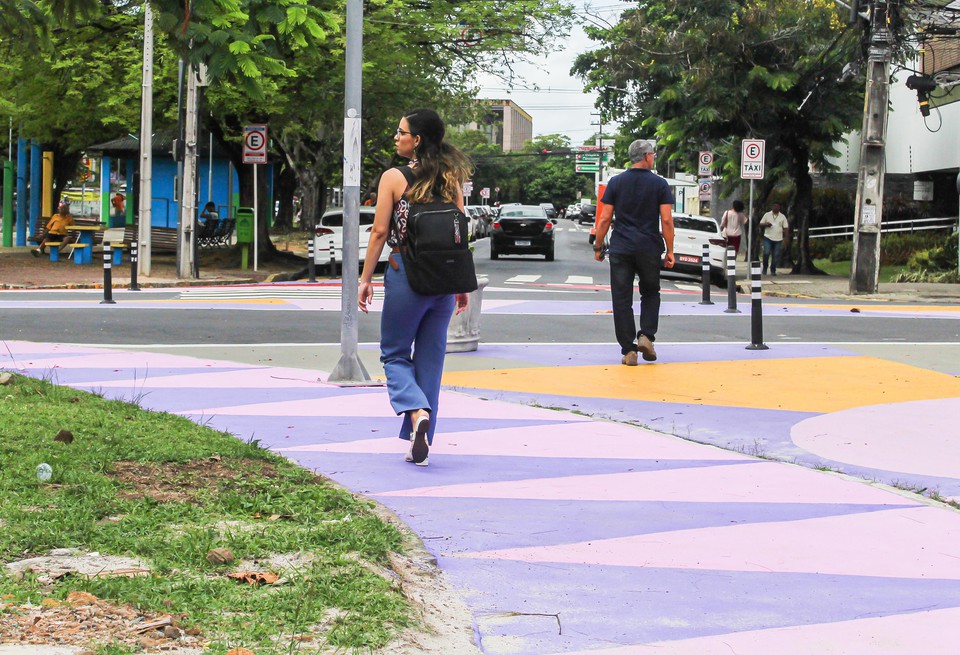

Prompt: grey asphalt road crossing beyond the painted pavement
xmin=0 ymin=220 xmax=960 ymax=345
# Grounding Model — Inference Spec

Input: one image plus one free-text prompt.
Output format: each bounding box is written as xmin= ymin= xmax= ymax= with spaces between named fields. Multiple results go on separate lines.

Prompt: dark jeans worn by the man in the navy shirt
xmin=609 ymin=253 xmax=660 ymax=355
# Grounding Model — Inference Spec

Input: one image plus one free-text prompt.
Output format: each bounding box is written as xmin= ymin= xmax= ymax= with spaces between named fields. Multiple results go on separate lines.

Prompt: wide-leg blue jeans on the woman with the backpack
xmin=380 ymin=255 xmax=454 ymax=444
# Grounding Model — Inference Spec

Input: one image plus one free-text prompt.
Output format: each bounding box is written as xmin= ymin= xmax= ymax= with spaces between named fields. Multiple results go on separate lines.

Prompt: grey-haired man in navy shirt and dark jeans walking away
xmin=593 ymin=139 xmax=673 ymax=366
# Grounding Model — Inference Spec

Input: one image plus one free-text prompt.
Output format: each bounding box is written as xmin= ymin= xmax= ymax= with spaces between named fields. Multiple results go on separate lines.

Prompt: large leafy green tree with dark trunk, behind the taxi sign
xmin=574 ymin=0 xmax=863 ymax=272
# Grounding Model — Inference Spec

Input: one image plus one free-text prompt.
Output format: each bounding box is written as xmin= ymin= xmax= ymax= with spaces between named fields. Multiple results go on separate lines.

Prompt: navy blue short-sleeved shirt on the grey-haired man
xmin=602 ymin=168 xmax=673 ymax=255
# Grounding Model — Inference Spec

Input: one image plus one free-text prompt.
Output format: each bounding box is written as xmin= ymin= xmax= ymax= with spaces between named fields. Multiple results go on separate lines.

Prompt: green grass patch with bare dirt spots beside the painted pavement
xmin=0 ymin=376 xmax=415 ymax=655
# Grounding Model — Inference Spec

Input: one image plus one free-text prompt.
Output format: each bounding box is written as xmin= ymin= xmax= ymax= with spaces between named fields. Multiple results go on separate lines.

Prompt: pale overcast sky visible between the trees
xmin=478 ymin=0 xmax=627 ymax=145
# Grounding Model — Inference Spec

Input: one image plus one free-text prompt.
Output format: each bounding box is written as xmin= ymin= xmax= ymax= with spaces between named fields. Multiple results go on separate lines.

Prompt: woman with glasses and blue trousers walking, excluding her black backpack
xmin=357 ymin=109 xmax=472 ymax=466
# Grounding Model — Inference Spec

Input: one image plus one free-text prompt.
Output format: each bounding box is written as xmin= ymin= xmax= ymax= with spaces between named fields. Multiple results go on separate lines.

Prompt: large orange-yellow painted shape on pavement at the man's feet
xmin=443 ymin=357 xmax=960 ymax=413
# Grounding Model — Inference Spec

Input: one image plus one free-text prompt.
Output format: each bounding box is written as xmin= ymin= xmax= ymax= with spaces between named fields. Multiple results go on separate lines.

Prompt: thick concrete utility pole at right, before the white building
xmin=850 ymin=0 xmax=894 ymax=293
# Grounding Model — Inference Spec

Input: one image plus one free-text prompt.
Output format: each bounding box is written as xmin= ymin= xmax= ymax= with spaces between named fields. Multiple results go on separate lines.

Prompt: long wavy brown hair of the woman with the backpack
xmin=403 ymin=109 xmax=473 ymax=203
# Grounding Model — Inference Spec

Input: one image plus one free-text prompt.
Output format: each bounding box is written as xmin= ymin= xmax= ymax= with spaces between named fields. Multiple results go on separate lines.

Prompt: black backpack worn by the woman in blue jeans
xmin=400 ymin=166 xmax=477 ymax=296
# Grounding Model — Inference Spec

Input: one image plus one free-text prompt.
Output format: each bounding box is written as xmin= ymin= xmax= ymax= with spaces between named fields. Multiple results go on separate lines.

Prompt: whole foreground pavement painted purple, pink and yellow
xmin=0 ymin=338 xmax=960 ymax=655
